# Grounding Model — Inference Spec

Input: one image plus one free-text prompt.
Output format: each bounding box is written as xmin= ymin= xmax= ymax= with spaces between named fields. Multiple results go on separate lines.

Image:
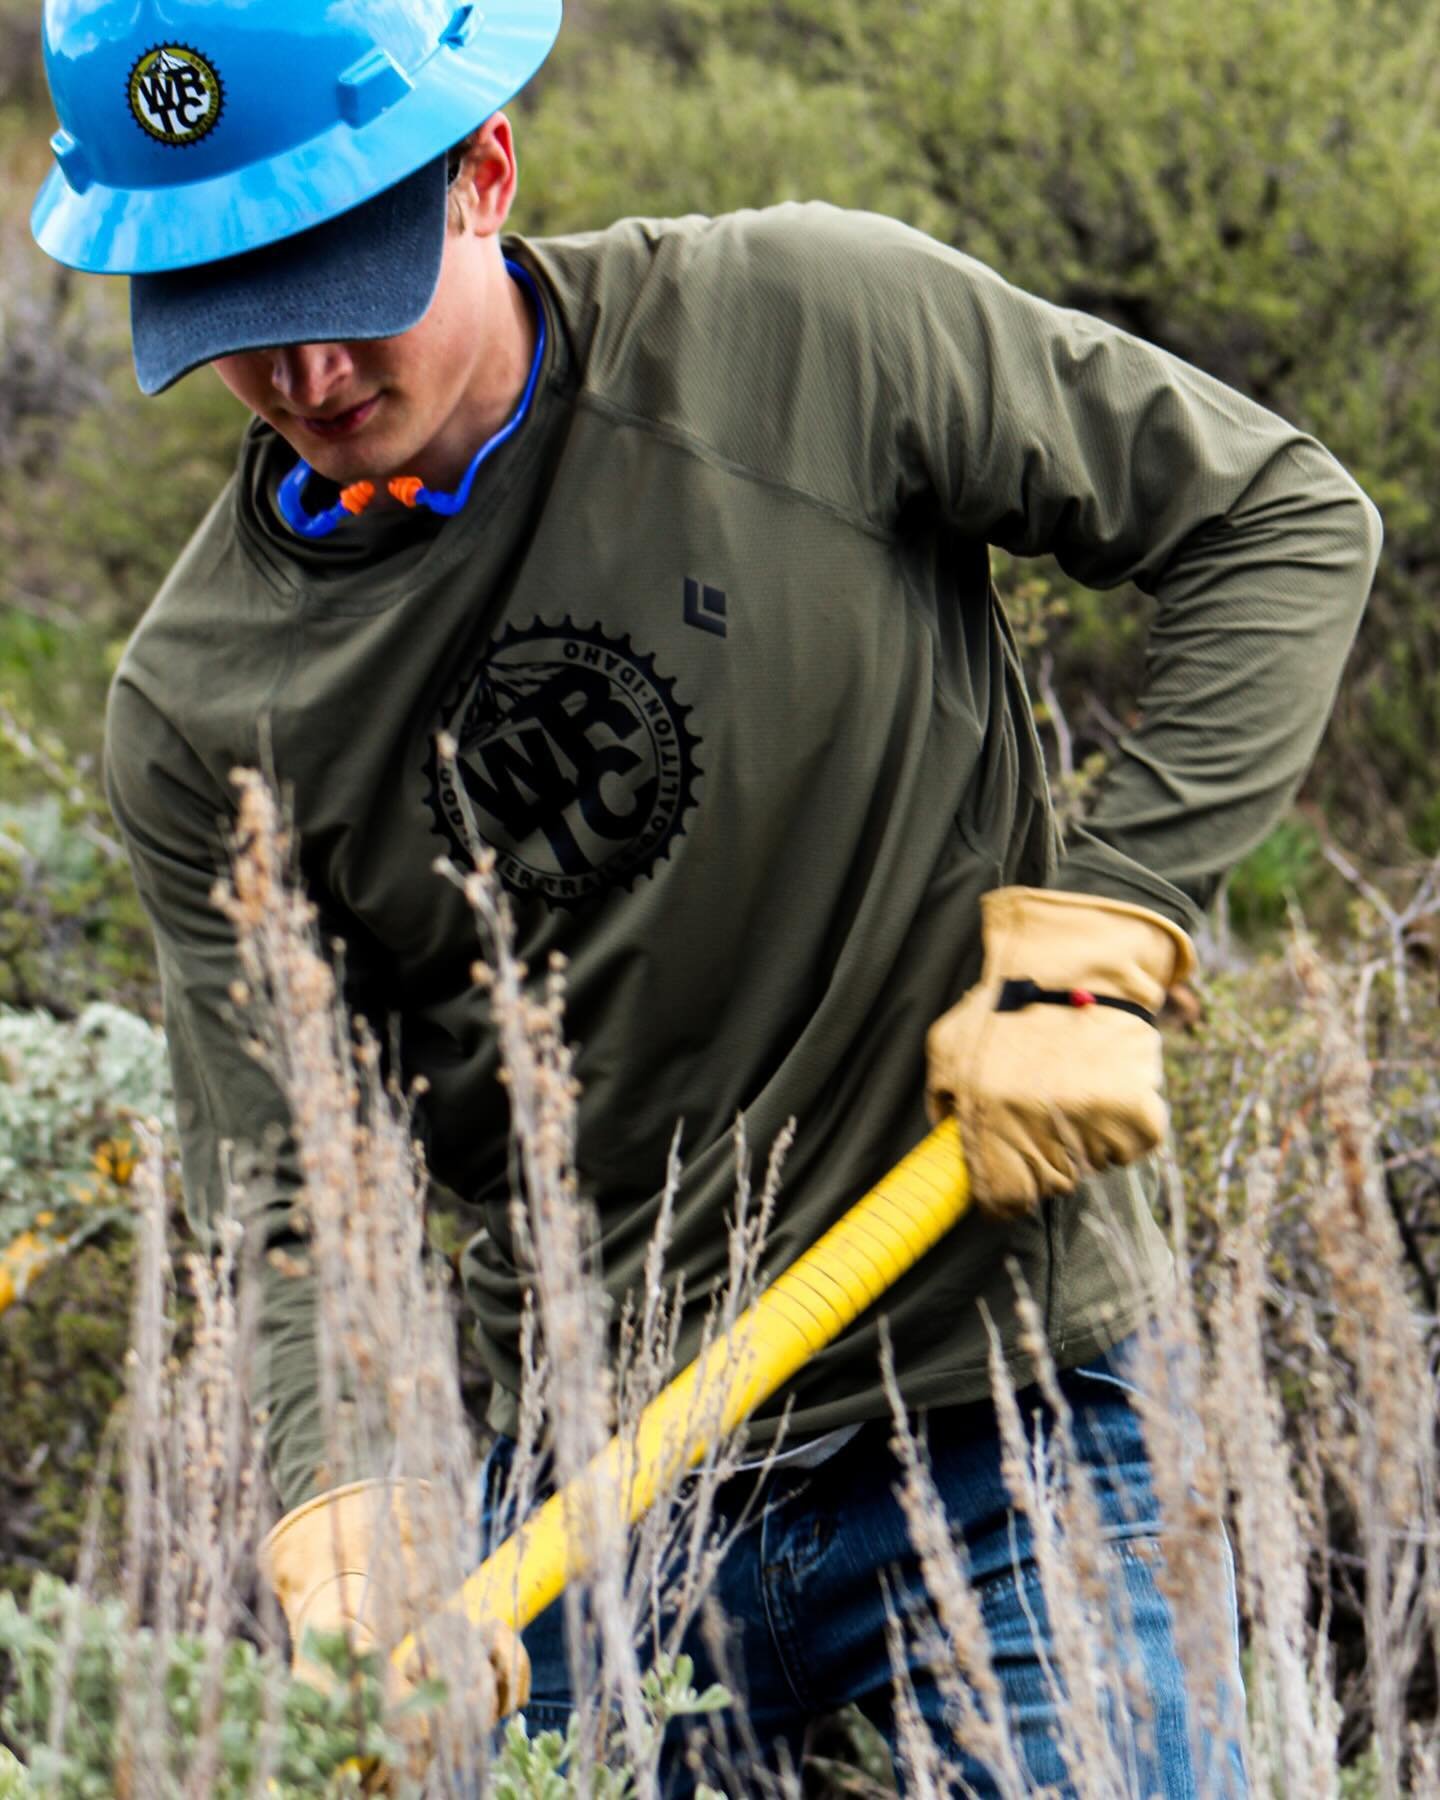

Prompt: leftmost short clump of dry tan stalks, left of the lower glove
xmin=38 ymin=1123 xmax=288 ymax=1800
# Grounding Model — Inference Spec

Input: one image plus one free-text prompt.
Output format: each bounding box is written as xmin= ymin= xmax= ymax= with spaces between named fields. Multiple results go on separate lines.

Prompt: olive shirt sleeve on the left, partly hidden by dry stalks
xmin=104 ymin=671 xmax=333 ymax=1510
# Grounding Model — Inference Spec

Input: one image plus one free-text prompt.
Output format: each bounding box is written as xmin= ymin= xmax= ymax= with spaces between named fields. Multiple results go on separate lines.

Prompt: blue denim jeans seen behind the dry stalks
xmin=482 ymin=1346 xmax=1246 ymax=1800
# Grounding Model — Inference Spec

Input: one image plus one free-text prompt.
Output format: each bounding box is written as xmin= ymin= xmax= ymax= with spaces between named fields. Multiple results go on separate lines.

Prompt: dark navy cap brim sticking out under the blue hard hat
xmin=130 ymin=157 xmax=448 ymax=394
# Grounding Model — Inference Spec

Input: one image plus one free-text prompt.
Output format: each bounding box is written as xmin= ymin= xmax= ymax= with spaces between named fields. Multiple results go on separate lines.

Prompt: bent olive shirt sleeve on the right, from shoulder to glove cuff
xmin=866 ymin=216 xmax=1381 ymax=929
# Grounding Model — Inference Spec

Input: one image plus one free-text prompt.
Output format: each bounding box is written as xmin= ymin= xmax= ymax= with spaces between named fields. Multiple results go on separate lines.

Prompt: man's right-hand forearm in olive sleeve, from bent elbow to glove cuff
xmin=1058 ymin=437 xmax=1381 ymax=927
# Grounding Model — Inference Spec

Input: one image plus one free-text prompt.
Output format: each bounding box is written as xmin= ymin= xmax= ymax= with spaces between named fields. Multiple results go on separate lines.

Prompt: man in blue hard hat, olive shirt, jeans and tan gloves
xmin=36 ymin=0 xmax=1379 ymax=1793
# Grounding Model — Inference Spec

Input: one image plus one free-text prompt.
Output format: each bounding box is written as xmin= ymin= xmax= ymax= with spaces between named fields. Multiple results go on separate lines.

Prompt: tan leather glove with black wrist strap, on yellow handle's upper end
xmin=927 ymin=887 xmax=1195 ymax=1219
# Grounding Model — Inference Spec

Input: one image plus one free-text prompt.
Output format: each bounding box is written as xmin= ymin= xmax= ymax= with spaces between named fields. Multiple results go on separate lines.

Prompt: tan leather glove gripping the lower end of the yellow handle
xmin=257 ymin=1481 xmax=529 ymax=1748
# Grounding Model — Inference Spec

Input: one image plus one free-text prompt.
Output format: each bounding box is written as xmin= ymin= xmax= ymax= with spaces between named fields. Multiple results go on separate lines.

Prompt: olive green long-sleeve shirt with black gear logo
xmin=108 ymin=207 xmax=1379 ymax=1503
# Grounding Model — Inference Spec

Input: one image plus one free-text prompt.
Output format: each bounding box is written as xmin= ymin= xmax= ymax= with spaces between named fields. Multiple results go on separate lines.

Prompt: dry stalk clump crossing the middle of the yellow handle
xmin=437 ymin=740 xmax=792 ymax=1791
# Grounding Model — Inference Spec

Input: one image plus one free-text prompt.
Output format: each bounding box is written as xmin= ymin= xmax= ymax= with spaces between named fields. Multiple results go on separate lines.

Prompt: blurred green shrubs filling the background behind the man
xmin=0 ymin=0 xmax=1440 ymax=1771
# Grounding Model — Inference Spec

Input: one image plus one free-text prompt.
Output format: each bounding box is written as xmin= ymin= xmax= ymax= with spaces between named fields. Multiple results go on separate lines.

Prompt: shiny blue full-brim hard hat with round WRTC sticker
xmin=31 ymin=0 xmax=562 ymax=275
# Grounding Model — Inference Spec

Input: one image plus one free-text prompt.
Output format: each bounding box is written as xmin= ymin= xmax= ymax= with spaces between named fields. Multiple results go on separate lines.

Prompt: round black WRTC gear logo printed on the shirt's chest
xmin=427 ymin=619 xmax=702 ymax=905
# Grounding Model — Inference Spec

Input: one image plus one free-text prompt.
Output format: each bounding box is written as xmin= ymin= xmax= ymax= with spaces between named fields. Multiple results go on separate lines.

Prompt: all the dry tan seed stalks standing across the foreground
xmin=22 ymin=776 xmax=1440 ymax=1800
